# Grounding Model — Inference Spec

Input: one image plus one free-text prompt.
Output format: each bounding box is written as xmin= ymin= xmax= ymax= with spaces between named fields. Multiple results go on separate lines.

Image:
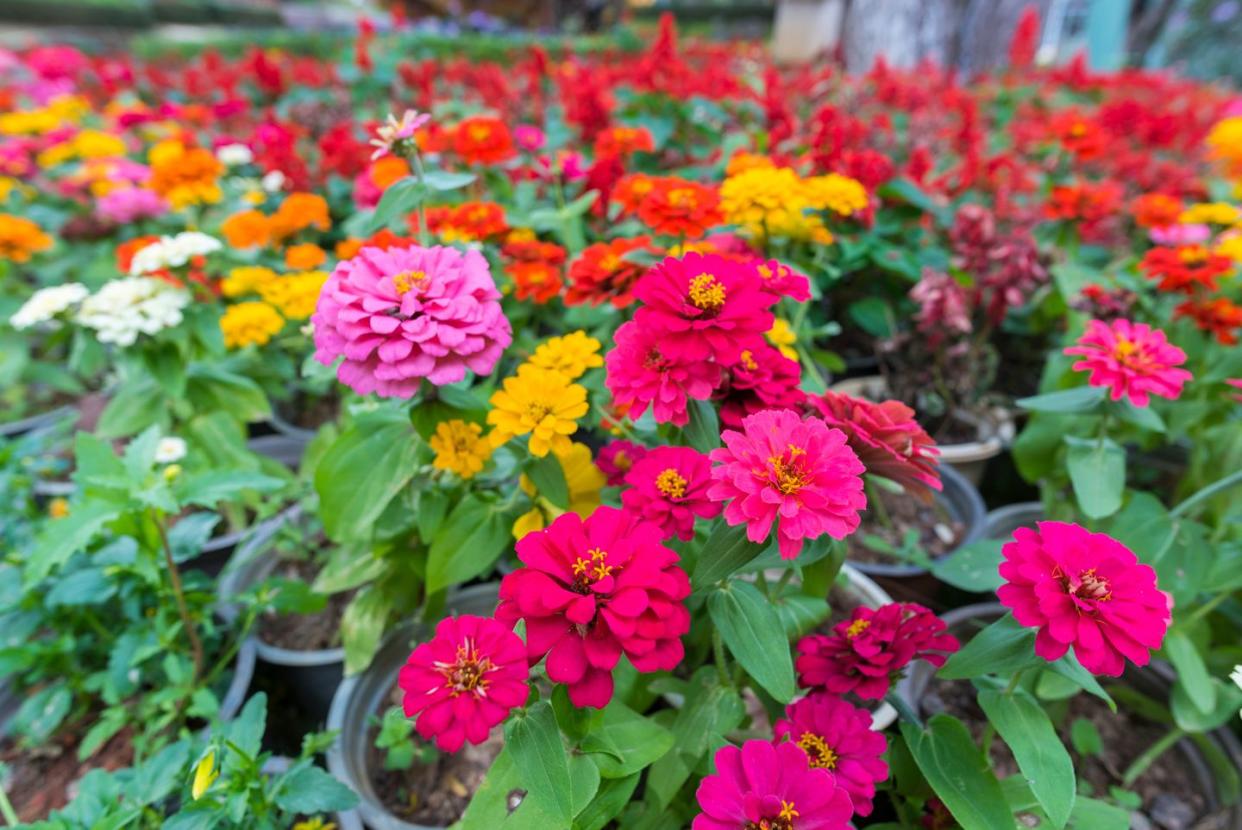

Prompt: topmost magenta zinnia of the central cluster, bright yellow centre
xmin=633 ymin=253 xmax=777 ymax=364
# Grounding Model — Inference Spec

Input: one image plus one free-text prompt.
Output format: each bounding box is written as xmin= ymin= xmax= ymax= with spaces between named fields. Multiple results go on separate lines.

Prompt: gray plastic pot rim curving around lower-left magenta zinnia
xmin=327 ymin=583 xmax=499 ymax=830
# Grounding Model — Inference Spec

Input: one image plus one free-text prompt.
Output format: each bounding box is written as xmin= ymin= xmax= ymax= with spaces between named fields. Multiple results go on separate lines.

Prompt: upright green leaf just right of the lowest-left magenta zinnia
xmin=504 ymin=701 xmax=574 ymax=826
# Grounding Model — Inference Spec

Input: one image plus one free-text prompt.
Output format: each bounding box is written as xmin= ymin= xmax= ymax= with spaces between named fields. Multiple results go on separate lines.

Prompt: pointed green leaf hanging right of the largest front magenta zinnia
xmin=707 ymin=580 xmax=794 ymax=703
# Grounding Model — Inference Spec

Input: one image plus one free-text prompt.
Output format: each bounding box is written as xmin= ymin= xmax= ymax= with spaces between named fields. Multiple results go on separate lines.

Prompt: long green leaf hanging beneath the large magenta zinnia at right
xmin=979 ymin=690 xmax=1077 ymax=828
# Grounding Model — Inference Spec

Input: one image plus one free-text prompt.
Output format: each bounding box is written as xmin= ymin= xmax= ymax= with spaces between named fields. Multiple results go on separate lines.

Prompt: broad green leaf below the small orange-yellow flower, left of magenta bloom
xmin=427 ymin=493 xmax=513 ymax=594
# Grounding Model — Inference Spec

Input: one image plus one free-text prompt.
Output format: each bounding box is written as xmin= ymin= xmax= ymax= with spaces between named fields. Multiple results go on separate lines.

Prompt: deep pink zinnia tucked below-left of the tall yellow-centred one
xmin=604 ymin=321 xmax=720 ymax=426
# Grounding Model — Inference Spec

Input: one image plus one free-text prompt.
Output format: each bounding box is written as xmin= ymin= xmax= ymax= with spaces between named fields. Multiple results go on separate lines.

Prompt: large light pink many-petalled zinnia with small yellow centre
xmin=311 ymin=246 xmax=513 ymax=398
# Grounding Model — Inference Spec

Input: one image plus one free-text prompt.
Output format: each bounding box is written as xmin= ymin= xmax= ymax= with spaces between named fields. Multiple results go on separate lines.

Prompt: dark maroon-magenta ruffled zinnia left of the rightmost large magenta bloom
xmin=794 ymin=603 xmax=960 ymax=701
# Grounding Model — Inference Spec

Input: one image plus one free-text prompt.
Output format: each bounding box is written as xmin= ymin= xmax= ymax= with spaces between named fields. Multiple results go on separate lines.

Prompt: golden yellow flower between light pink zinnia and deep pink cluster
xmin=487 ymin=367 xmax=590 ymax=457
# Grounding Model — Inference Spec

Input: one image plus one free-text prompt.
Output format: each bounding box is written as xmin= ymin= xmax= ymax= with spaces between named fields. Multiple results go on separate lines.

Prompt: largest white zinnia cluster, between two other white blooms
xmin=77 ymin=277 xmax=190 ymax=345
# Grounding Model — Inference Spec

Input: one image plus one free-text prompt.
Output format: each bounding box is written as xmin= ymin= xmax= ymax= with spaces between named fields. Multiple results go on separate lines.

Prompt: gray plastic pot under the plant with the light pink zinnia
xmin=220 ymin=506 xmax=345 ymax=719
